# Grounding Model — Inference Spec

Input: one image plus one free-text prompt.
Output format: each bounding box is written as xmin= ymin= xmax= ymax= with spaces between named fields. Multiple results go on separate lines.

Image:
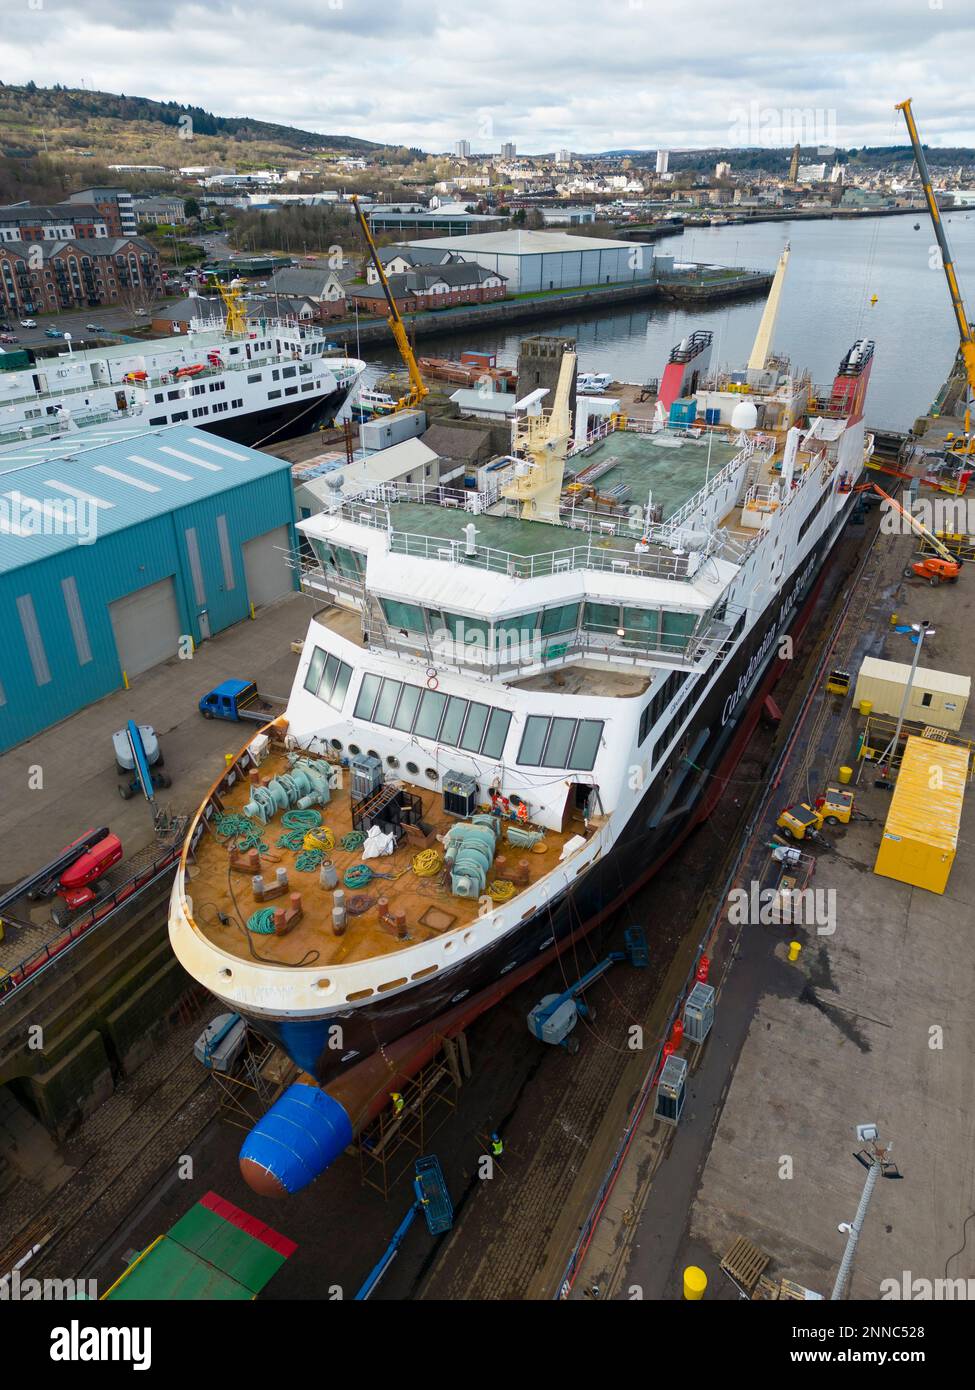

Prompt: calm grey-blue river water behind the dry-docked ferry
xmin=366 ymin=210 xmax=975 ymax=430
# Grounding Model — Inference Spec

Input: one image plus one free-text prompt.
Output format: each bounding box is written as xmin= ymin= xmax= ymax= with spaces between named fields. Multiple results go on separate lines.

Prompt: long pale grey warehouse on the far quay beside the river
xmin=409 ymin=231 xmax=654 ymax=295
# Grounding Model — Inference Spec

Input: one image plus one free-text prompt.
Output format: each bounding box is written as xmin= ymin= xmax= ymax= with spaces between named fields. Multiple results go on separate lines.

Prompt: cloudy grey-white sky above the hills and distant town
xmin=0 ymin=0 xmax=975 ymax=153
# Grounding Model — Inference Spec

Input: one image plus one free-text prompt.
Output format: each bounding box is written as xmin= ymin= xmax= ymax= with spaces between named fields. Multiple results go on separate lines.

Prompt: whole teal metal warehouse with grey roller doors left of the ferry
xmin=0 ymin=425 xmax=296 ymax=749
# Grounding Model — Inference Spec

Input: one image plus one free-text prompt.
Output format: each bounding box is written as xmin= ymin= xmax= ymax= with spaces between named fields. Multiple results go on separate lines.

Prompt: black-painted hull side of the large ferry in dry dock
xmin=249 ymin=498 xmax=853 ymax=1083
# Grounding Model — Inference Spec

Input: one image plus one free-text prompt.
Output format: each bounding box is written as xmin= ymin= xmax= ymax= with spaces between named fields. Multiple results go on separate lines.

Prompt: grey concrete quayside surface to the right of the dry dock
xmin=574 ymin=511 xmax=975 ymax=1300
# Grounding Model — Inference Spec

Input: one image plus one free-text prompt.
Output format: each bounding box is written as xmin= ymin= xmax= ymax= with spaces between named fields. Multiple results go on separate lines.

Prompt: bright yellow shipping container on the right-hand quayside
xmin=873 ymin=737 xmax=968 ymax=892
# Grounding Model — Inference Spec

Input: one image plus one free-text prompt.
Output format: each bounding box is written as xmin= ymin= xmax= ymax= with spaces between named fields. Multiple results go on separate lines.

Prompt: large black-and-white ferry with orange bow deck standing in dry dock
xmin=170 ymin=252 xmax=873 ymax=1187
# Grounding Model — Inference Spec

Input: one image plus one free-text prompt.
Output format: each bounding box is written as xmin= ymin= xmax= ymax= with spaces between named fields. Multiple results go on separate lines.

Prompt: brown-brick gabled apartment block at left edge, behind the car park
xmin=0 ymin=236 xmax=163 ymax=316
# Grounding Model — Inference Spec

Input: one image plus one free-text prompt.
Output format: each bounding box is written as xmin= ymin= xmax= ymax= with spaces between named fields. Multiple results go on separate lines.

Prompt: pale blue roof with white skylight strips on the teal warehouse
xmin=0 ymin=425 xmax=291 ymax=574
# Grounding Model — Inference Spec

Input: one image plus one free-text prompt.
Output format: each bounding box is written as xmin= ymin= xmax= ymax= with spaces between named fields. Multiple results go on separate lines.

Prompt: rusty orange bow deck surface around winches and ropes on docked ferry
xmin=188 ymin=745 xmax=584 ymax=966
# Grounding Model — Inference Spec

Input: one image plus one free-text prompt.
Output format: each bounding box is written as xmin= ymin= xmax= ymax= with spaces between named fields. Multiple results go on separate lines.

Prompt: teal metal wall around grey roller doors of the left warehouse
xmin=0 ymin=467 xmax=298 ymax=751
